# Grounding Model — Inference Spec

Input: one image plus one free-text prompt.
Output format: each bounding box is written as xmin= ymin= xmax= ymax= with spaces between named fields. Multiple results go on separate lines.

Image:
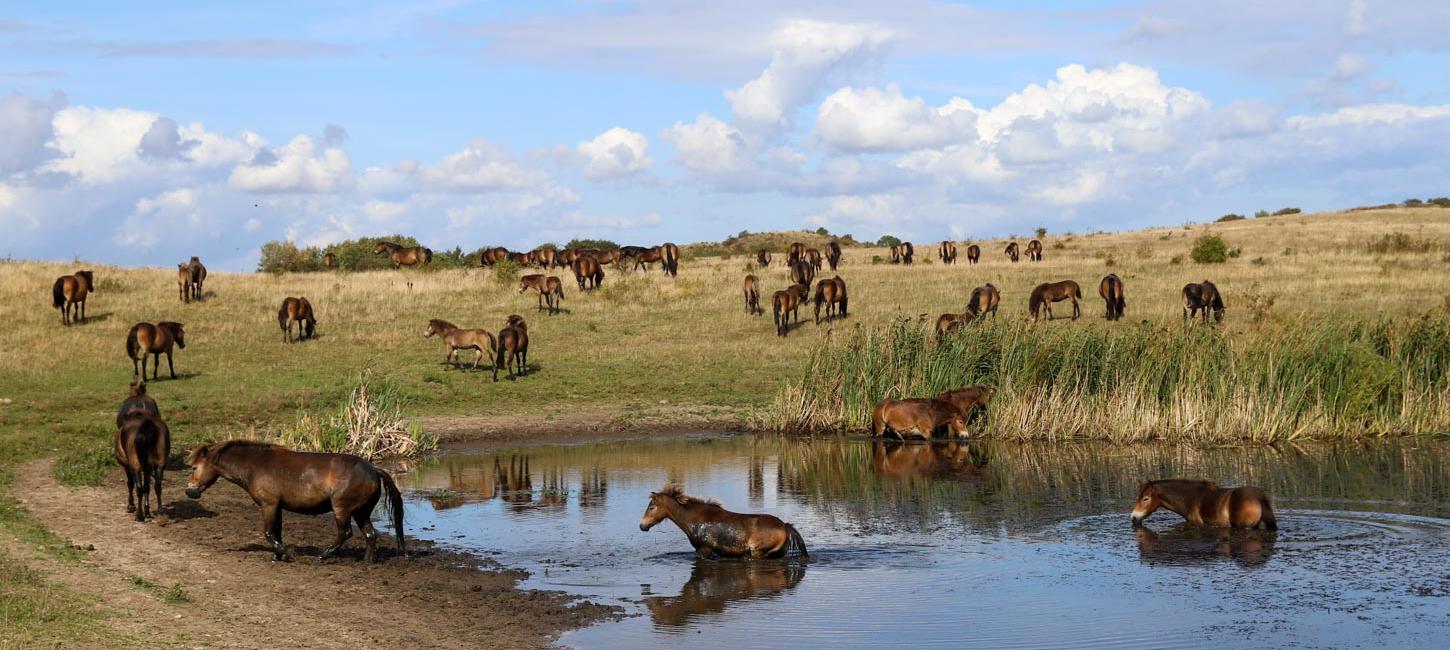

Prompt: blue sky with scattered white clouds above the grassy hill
xmin=0 ymin=0 xmax=1450 ymax=270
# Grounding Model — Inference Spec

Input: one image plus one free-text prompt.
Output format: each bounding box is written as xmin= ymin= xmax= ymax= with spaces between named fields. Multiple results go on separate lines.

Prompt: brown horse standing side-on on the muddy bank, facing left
xmin=186 ymin=440 xmax=407 ymax=561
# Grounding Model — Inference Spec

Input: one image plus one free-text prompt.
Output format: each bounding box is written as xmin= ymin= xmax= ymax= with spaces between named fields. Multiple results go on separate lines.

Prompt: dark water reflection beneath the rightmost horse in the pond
xmin=1134 ymin=524 xmax=1279 ymax=567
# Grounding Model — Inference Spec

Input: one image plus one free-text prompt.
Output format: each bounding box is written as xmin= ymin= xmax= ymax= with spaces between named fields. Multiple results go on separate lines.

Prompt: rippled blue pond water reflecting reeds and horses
xmin=405 ymin=437 xmax=1450 ymax=649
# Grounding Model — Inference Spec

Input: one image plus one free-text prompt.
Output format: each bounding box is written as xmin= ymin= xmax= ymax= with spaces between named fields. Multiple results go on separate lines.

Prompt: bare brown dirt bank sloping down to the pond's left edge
xmin=17 ymin=461 xmax=615 ymax=649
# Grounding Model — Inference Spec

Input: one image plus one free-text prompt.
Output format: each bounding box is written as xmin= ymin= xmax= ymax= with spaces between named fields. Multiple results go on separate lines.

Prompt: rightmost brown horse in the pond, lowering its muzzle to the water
xmin=1131 ymin=479 xmax=1279 ymax=531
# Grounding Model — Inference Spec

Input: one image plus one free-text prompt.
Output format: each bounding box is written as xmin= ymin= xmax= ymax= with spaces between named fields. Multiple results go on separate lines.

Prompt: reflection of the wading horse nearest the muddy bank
xmin=645 ymin=560 xmax=806 ymax=628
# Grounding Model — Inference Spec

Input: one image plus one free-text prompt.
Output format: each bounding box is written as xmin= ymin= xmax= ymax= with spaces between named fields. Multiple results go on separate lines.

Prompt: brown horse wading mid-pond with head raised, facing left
xmin=639 ymin=486 xmax=809 ymax=559
